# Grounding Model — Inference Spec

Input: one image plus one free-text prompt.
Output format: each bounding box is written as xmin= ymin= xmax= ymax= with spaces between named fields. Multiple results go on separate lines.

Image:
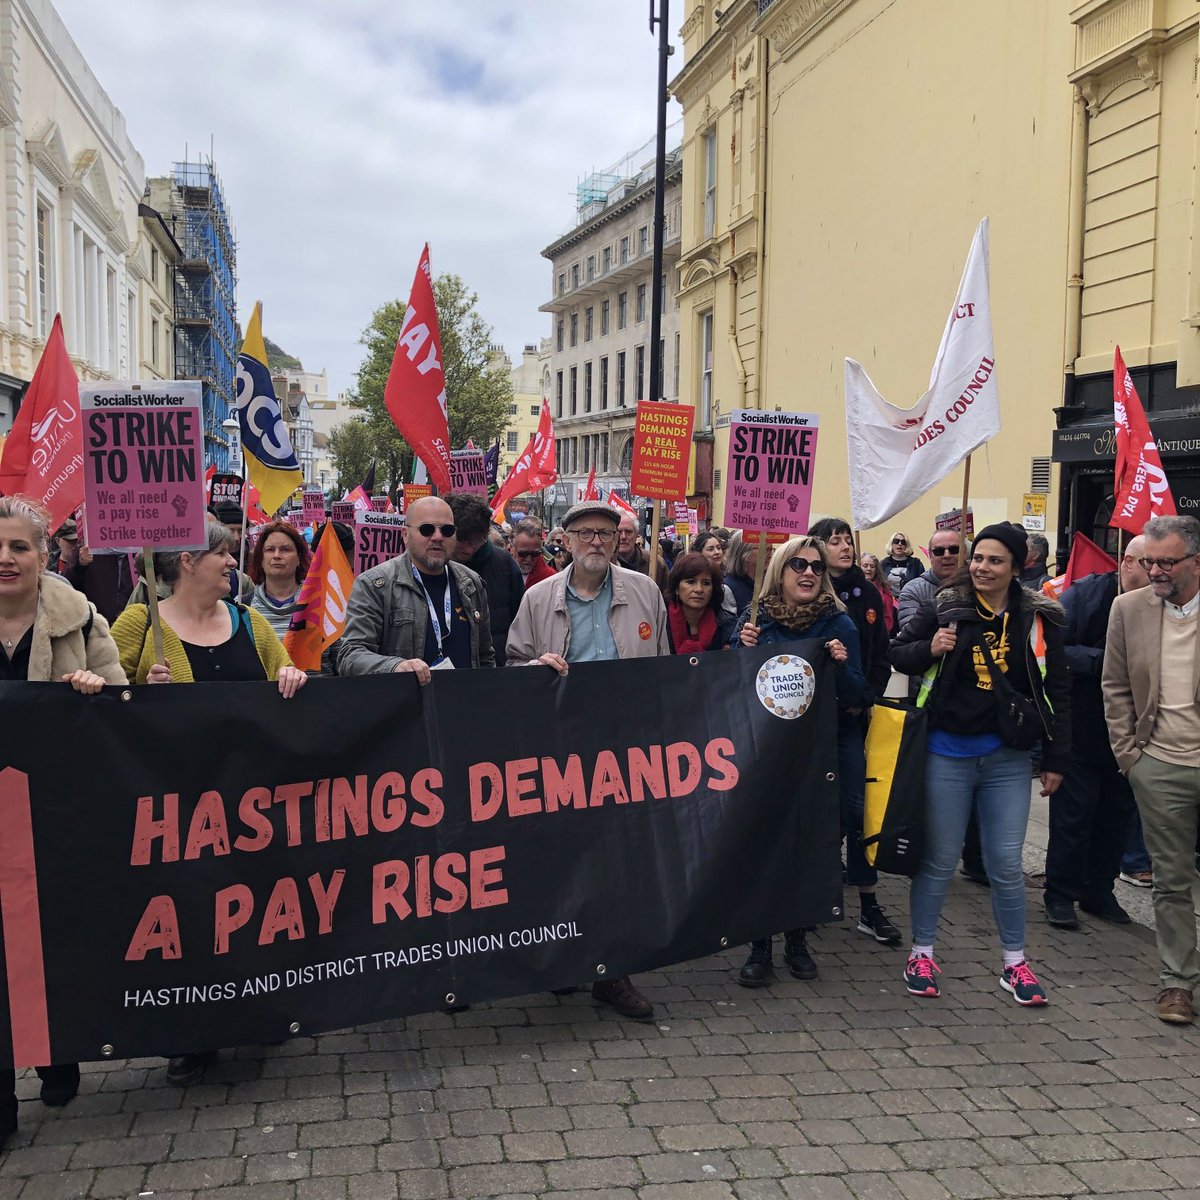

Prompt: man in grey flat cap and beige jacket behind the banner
xmin=508 ymin=500 xmax=671 ymax=1020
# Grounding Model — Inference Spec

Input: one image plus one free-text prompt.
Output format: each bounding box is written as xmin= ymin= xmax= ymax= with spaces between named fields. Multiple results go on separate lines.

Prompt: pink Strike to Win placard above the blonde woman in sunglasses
xmin=725 ymin=409 xmax=818 ymax=534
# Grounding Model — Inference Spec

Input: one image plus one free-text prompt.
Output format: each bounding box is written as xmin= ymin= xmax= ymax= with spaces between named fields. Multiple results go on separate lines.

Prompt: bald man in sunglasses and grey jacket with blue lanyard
xmin=337 ymin=496 xmax=496 ymax=685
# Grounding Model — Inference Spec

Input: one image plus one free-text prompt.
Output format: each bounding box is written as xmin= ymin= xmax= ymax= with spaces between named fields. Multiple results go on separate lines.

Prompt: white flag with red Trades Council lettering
xmin=846 ymin=217 xmax=1000 ymax=529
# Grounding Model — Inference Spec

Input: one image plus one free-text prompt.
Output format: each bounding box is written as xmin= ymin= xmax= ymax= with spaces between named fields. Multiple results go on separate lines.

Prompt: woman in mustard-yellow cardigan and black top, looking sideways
xmin=113 ymin=521 xmax=307 ymax=697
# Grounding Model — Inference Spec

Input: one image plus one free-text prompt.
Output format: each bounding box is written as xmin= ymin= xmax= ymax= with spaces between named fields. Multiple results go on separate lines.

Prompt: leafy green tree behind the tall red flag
xmin=343 ymin=275 xmax=512 ymax=491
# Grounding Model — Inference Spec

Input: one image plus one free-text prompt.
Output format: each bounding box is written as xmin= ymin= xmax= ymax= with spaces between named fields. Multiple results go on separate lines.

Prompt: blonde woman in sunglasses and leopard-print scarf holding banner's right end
xmin=734 ymin=538 xmax=870 ymax=988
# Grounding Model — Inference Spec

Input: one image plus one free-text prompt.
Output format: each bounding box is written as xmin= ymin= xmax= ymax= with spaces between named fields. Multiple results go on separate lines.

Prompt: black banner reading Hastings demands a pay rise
xmin=0 ymin=642 xmax=841 ymax=1066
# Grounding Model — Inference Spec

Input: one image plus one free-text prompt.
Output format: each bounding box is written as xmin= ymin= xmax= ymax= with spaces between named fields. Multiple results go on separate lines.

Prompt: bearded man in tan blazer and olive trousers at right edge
xmin=1103 ymin=517 xmax=1200 ymax=1025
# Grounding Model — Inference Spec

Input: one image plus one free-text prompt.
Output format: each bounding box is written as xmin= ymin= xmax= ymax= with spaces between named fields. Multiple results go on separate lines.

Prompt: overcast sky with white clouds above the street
xmin=54 ymin=0 xmax=684 ymax=391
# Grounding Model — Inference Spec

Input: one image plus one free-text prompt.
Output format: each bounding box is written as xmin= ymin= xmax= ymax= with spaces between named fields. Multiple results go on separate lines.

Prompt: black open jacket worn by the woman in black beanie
xmin=890 ymin=584 xmax=1072 ymax=774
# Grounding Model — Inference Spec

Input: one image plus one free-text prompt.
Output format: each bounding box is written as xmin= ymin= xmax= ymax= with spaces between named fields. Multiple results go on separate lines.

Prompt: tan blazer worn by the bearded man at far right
xmin=1102 ymin=588 xmax=1200 ymax=775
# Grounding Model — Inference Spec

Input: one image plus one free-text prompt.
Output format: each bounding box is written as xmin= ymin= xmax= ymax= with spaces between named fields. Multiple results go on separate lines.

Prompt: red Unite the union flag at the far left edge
xmin=0 ymin=316 xmax=83 ymax=529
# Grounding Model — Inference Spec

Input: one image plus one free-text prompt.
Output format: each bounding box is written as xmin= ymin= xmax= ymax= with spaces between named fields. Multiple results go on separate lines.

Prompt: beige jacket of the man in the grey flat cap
xmin=508 ymin=564 xmax=671 ymax=666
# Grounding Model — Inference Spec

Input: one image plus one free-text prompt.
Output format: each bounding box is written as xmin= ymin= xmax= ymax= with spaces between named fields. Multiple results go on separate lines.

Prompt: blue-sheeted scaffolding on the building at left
xmin=168 ymin=160 xmax=238 ymax=470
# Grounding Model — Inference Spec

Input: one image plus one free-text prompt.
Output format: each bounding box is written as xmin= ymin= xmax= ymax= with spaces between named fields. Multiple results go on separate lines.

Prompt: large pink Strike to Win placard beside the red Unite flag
xmin=79 ymin=380 xmax=208 ymax=550
